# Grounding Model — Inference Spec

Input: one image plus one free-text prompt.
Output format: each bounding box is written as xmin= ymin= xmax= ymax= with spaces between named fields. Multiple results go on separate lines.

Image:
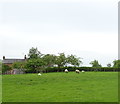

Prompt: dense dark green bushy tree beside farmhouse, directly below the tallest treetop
xmin=26 ymin=58 xmax=45 ymax=72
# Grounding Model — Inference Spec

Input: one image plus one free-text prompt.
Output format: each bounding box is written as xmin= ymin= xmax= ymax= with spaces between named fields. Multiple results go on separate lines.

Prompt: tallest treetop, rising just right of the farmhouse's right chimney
xmin=28 ymin=47 xmax=42 ymax=59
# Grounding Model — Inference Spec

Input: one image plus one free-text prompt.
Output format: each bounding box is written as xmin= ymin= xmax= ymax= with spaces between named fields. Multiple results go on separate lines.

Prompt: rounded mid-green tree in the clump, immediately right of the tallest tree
xmin=42 ymin=54 xmax=56 ymax=67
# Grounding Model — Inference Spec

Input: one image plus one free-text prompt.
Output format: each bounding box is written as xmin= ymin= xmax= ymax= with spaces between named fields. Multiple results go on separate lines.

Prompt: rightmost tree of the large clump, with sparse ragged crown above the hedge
xmin=67 ymin=54 xmax=82 ymax=67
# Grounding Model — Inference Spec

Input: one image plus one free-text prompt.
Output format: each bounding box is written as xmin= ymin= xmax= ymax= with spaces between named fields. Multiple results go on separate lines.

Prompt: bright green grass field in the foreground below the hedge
xmin=2 ymin=72 xmax=118 ymax=102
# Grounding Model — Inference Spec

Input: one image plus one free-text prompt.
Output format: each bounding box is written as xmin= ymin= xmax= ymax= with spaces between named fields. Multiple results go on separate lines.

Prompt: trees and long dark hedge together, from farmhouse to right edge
xmin=9 ymin=47 xmax=120 ymax=73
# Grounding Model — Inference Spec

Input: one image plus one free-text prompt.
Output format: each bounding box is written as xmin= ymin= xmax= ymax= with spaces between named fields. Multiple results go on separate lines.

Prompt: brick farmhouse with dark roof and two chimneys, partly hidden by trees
xmin=2 ymin=55 xmax=27 ymax=74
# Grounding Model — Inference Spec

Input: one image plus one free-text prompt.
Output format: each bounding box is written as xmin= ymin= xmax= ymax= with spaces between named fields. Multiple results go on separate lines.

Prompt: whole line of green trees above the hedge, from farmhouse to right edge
xmin=2 ymin=47 xmax=120 ymax=73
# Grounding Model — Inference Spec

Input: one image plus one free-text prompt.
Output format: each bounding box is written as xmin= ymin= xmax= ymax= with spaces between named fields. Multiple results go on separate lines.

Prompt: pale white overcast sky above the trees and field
xmin=0 ymin=0 xmax=118 ymax=66
